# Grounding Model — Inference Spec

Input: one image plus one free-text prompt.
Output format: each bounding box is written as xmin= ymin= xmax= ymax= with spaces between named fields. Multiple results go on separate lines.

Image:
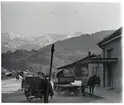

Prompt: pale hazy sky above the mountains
xmin=1 ymin=2 xmax=121 ymax=36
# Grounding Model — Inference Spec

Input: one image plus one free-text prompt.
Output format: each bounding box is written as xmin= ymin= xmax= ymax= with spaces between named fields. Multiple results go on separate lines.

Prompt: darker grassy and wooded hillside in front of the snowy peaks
xmin=2 ymin=31 xmax=112 ymax=72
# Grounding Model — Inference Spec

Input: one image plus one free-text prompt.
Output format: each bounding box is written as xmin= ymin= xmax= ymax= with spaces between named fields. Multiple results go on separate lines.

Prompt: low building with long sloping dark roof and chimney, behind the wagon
xmin=57 ymin=52 xmax=96 ymax=79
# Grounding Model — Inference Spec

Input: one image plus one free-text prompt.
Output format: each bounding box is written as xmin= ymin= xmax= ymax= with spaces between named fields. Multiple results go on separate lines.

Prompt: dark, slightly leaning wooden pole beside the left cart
xmin=44 ymin=44 xmax=55 ymax=103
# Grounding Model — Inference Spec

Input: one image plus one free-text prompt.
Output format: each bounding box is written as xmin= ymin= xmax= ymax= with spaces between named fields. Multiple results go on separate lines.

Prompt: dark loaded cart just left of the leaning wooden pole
xmin=23 ymin=77 xmax=50 ymax=102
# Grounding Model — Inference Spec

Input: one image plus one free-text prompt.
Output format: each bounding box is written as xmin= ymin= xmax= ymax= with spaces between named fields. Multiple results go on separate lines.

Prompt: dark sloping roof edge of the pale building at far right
xmin=97 ymin=27 xmax=122 ymax=46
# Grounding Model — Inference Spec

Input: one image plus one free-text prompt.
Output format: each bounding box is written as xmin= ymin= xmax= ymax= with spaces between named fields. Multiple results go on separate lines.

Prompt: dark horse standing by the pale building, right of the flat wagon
xmin=87 ymin=75 xmax=101 ymax=95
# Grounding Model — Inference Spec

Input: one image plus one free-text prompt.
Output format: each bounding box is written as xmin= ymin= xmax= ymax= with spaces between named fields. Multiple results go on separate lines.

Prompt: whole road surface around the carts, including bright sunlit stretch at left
xmin=2 ymin=79 xmax=103 ymax=103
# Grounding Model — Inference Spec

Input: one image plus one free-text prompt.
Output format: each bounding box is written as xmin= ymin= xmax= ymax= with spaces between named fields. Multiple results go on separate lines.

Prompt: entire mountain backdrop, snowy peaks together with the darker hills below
xmin=2 ymin=30 xmax=114 ymax=72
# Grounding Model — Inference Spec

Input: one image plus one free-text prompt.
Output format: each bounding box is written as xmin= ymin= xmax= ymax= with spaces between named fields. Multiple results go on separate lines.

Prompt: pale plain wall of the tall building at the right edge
xmin=103 ymin=38 xmax=122 ymax=90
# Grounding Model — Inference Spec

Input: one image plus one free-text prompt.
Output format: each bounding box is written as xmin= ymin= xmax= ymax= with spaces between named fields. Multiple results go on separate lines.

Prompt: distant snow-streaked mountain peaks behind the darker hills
xmin=1 ymin=32 xmax=77 ymax=52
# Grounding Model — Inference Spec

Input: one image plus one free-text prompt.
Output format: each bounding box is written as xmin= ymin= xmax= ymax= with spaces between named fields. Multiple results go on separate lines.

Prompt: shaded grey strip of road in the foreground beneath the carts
xmin=2 ymin=90 xmax=104 ymax=103
